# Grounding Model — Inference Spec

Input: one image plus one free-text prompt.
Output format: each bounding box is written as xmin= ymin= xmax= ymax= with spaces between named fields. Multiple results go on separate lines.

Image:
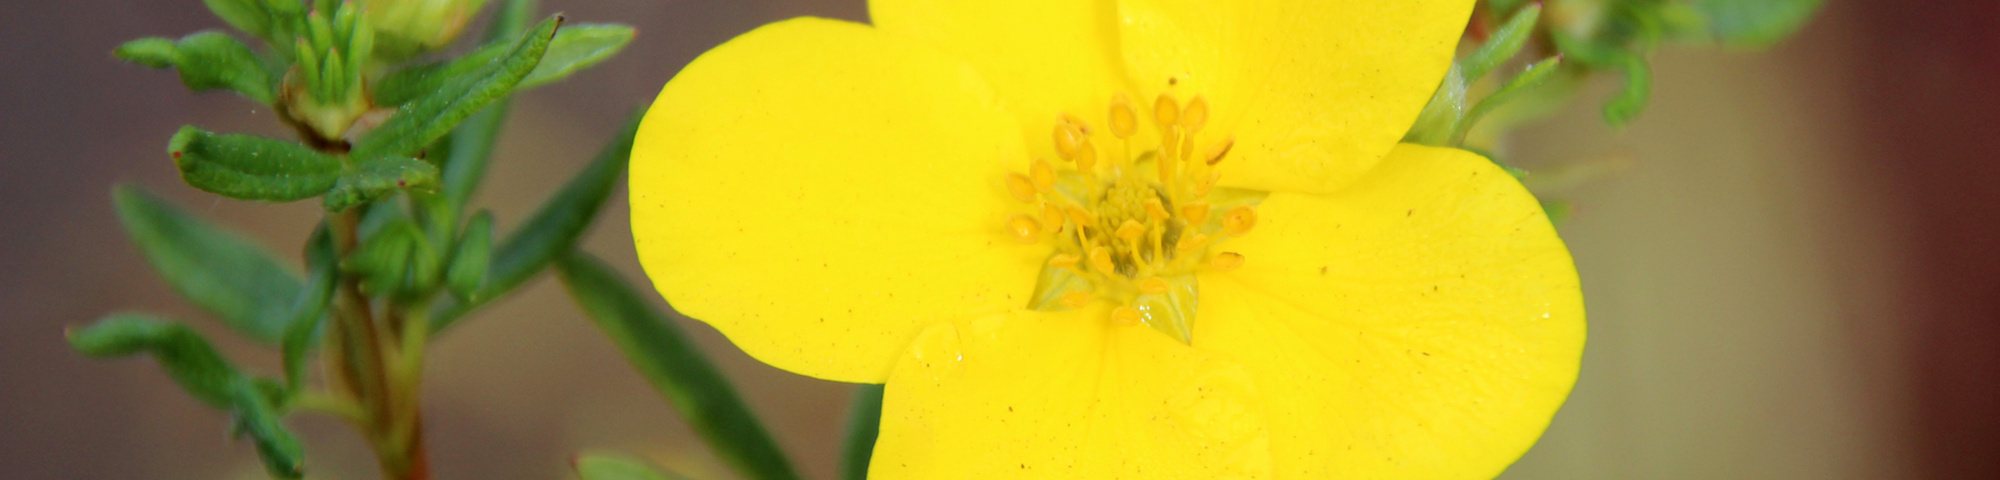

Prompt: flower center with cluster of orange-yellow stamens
xmin=1006 ymin=94 xmax=1262 ymax=342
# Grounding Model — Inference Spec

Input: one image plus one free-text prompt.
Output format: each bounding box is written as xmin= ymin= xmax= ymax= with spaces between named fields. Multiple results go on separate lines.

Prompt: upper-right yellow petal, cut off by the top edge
xmin=1120 ymin=0 xmax=1472 ymax=192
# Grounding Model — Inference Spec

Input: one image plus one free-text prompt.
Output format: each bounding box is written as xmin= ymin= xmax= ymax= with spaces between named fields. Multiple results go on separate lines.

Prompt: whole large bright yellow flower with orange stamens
xmin=632 ymin=0 xmax=1584 ymax=478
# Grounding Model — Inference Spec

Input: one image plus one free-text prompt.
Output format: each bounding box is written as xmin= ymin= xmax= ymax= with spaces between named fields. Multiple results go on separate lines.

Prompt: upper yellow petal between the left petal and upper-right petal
xmin=868 ymin=0 xmax=1128 ymax=158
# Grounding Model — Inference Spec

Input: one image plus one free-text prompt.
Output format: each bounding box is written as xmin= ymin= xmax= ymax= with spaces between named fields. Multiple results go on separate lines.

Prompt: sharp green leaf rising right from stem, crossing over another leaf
xmin=352 ymin=14 xmax=562 ymax=158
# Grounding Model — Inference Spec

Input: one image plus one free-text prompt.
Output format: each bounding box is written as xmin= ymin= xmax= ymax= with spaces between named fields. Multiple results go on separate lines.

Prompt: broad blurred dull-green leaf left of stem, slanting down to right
xmin=112 ymin=186 xmax=302 ymax=344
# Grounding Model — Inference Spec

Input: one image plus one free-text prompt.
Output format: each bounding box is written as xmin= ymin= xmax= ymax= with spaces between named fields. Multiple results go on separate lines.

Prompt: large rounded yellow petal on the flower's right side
xmin=1194 ymin=144 xmax=1584 ymax=478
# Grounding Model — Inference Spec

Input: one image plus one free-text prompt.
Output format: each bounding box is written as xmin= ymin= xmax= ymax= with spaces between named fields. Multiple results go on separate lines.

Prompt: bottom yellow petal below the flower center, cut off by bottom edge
xmin=868 ymin=308 xmax=1270 ymax=480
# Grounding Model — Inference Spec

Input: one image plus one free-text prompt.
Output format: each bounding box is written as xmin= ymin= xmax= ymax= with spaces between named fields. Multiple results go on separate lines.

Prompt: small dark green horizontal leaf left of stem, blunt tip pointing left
xmin=166 ymin=126 xmax=340 ymax=202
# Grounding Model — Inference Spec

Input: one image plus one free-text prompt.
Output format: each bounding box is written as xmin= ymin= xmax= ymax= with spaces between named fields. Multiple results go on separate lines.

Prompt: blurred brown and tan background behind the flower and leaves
xmin=0 ymin=0 xmax=2000 ymax=478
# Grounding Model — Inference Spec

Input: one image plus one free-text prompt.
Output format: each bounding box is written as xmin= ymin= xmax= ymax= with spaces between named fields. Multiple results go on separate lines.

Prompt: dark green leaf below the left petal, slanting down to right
xmin=556 ymin=252 xmax=798 ymax=480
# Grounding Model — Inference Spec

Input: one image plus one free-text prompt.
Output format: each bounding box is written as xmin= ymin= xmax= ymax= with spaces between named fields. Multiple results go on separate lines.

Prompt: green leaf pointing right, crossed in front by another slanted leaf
xmin=376 ymin=24 xmax=636 ymax=106
